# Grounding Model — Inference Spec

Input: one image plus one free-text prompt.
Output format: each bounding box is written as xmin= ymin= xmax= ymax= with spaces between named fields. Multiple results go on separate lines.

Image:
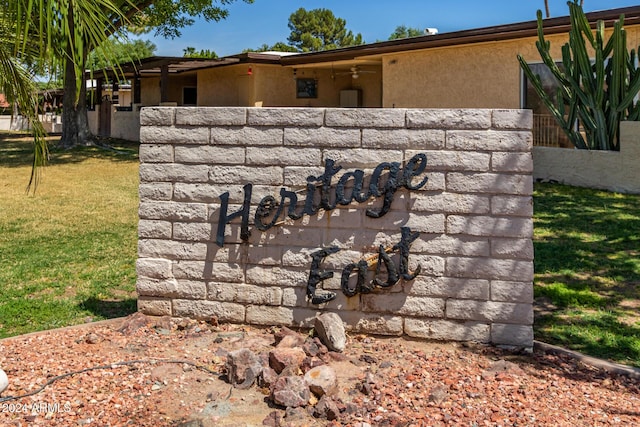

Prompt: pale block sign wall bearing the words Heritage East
xmin=137 ymin=107 xmax=533 ymax=347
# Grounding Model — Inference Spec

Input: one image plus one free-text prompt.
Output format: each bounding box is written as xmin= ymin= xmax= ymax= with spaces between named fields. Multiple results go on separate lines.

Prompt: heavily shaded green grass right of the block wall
xmin=534 ymin=184 xmax=640 ymax=367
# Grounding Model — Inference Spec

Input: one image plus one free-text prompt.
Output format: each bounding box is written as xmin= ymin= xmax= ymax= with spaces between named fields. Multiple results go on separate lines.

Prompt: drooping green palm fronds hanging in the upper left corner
xmin=0 ymin=0 xmax=124 ymax=188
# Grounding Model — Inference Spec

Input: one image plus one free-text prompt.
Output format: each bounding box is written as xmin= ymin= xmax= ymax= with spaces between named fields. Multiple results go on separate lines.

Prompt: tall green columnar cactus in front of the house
xmin=518 ymin=1 xmax=640 ymax=151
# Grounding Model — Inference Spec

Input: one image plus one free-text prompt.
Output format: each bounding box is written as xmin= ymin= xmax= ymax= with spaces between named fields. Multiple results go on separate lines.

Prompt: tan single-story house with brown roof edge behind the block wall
xmin=94 ymin=6 xmax=640 ymax=145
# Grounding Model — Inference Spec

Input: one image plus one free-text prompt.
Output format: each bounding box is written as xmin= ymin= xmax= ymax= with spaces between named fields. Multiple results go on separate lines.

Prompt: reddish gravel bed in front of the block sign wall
xmin=0 ymin=316 xmax=640 ymax=427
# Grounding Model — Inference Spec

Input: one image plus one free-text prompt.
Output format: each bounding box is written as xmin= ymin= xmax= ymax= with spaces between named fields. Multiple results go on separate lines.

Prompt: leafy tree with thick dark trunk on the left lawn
xmin=56 ymin=0 xmax=253 ymax=148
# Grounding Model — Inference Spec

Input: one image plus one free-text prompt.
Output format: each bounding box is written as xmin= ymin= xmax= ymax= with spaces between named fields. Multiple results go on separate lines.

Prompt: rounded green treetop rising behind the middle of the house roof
xmin=287 ymin=7 xmax=364 ymax=52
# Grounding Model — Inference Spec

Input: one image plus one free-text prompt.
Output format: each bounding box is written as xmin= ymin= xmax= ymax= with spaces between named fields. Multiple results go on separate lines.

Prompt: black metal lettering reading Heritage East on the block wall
xmin=216 ymin=153 xmax=428 ymax=304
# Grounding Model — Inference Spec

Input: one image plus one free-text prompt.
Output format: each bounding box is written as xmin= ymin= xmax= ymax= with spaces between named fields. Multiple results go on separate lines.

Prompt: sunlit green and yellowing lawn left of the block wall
xmin=0 ymin=132 xmax=138 ymax=337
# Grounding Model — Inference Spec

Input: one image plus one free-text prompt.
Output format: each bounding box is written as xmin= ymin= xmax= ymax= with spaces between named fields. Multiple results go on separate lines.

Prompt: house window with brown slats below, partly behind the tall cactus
xmin=522 ymin=63 xmax=573 ymax=148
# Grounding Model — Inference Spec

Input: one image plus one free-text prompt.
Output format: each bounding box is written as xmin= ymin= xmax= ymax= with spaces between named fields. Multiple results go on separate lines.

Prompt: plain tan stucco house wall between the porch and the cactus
xmin=382 ymin=26 xmax=640 ymax=108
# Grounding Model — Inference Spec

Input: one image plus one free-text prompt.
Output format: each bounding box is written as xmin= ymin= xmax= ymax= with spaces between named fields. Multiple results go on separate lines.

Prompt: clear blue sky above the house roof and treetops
xmin=140 ymin=0 xmax=640 ymax=56
